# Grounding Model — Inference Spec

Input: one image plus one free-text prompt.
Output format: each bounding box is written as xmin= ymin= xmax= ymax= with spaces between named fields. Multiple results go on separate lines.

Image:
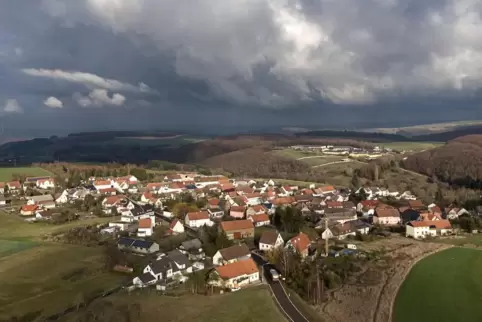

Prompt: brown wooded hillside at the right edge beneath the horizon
xmin=403 ymin=135 xmax=482 ymax=188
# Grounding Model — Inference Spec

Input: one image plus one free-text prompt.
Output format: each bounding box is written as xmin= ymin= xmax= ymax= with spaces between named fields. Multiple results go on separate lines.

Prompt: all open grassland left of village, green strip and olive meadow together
xmin=0 ymin=212 xmax=125 ymax=321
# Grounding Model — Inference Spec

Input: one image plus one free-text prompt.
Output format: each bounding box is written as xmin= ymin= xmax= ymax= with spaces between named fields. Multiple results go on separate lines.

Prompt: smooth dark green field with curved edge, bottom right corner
xmin=393 ymin=248 xmax=482 ymax=322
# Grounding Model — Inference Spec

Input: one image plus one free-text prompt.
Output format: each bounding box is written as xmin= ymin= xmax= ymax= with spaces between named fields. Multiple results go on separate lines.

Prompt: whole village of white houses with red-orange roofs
xmin=0 ymin=173 xmax=472 ymax=300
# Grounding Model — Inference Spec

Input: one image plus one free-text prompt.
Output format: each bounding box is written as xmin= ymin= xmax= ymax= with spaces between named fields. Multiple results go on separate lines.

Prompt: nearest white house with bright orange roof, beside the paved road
xmin=209 ymin=258 xmax=259 ymax=289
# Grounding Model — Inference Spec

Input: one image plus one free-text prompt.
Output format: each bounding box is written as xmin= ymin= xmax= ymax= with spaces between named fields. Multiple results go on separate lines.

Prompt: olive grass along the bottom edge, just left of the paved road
xmin=62 ymin=286 xmax=285 ymax=322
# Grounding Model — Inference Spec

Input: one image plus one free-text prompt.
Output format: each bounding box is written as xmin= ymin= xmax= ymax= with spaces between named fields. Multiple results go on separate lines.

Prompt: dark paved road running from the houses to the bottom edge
xmin=251 ymin=252 xmax=309 ymax=322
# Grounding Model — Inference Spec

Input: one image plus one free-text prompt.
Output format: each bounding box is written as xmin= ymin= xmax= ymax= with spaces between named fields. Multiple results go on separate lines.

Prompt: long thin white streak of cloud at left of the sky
xmin=22 ymin=68 xmax=154 ymax=93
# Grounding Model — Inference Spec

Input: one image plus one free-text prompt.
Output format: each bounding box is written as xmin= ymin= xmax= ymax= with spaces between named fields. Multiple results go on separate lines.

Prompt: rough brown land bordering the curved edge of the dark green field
xmin=320 ymin=236 xmax=450 ymax=322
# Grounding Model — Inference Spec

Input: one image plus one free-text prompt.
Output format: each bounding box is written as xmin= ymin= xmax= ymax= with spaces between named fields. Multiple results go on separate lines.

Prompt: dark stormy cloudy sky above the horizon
xmin=0 ymin=0 xmax=482 ymax=135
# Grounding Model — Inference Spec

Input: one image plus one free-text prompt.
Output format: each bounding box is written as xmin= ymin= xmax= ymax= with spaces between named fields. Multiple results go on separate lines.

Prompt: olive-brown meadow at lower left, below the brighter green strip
xmin=0 ymin=244 xmax=125 ymax=321
